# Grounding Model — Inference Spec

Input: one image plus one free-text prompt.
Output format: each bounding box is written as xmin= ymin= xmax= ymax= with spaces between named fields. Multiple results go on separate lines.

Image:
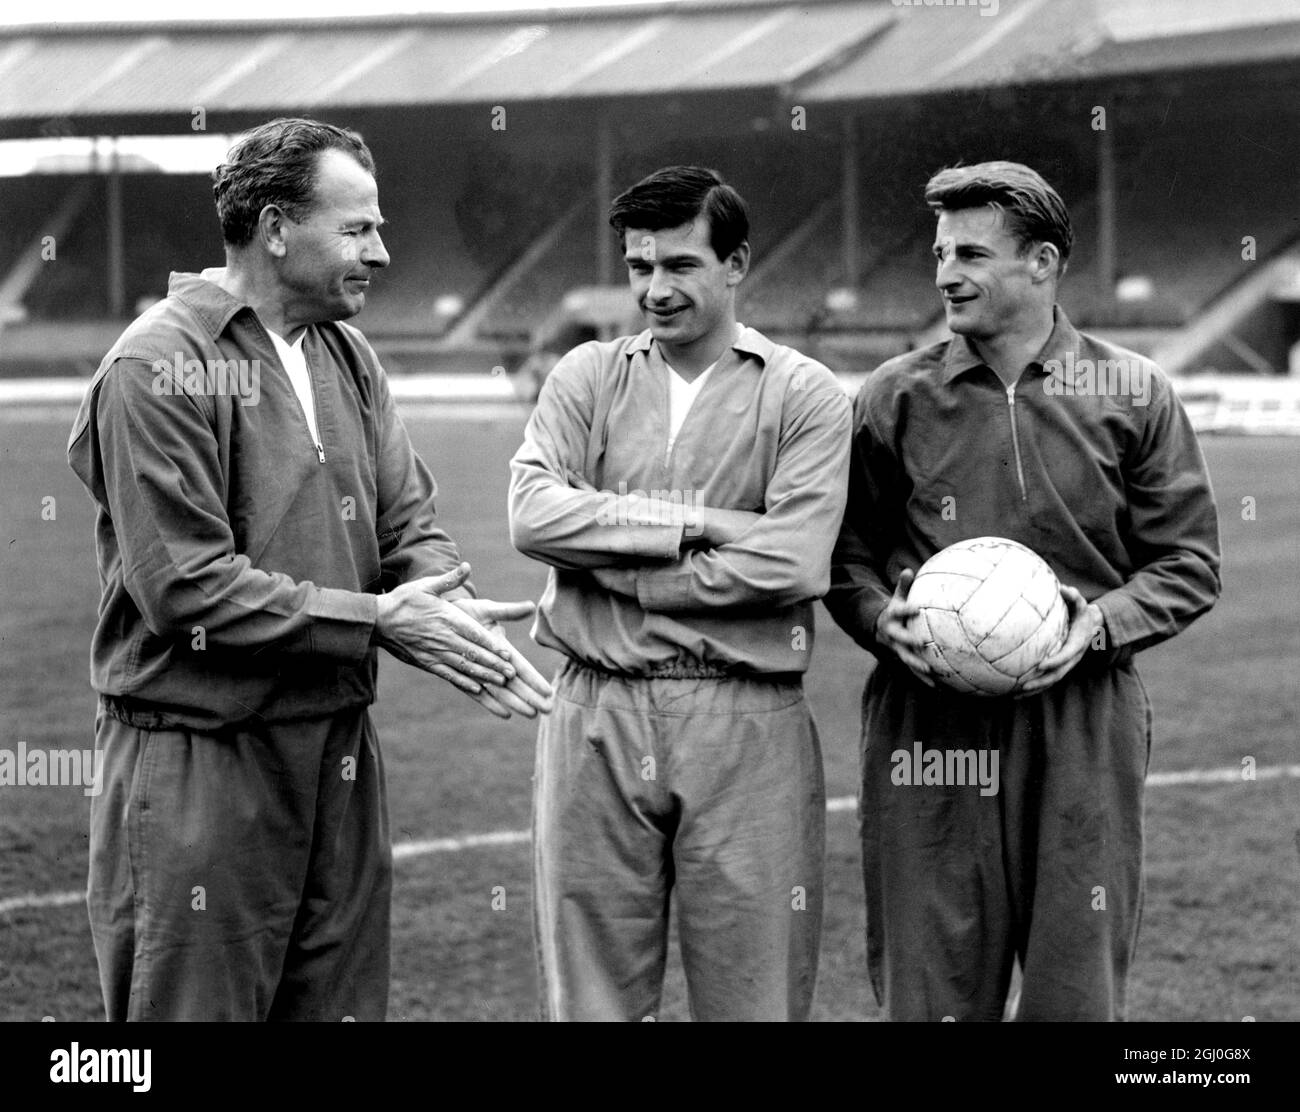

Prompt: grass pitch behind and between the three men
xmin=0 ymin=410 xmax=1300 ymax=1021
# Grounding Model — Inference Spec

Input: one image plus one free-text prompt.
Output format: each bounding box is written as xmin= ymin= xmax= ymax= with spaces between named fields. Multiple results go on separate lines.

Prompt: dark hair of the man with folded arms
xmin=610 ymin=166 xmax=749 ymax=260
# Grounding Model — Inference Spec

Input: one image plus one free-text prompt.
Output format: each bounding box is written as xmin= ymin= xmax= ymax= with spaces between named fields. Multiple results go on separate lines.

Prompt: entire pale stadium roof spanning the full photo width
xmin=0 ymin=0 xmax=1300 ymax=130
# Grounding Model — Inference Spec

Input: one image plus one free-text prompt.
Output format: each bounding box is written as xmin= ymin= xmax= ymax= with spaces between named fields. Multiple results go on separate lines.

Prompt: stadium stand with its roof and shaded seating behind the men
xmin=0 ymin=0 xmax=1300 ymax=376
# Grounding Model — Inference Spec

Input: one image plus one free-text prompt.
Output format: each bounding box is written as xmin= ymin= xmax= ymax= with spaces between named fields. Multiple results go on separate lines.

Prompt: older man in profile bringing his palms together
xmin=68 ymin=120 xmax=550 ymax=1021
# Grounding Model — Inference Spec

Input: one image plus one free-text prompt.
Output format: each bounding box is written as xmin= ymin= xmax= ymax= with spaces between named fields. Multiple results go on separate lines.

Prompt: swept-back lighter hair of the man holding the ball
xmin=926 ymin=161 xmax=1074 ymax=271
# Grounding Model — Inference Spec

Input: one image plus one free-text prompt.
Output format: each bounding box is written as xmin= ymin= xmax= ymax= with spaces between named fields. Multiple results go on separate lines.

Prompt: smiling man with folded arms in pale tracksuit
xmin=510 ymin=160 xmax=849 ymax=1020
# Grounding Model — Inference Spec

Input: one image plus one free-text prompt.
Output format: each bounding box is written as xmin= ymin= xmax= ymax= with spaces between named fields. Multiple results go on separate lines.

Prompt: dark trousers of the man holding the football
xmin=859 ymin=665 xmax=1151 ymax=1021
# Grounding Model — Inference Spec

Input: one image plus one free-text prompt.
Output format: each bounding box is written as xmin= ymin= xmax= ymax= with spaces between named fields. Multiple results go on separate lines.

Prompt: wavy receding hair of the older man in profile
xmin=212 ymin=118 xmax=374 ymax=247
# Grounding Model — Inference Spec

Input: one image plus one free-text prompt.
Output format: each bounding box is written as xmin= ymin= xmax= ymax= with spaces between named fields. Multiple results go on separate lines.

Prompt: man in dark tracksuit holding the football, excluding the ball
xmin=826 ymin=163 xmax=1219 ymax=1020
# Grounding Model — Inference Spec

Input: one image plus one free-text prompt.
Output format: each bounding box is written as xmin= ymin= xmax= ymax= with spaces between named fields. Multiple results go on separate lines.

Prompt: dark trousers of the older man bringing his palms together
xmin=88 ymin=709 xmax=393 ymax=1022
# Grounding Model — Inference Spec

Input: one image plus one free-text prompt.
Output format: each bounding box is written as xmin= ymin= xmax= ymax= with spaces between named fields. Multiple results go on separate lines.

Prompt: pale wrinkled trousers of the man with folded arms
xmin=533 ymin=662 xmax=826 ymax=1020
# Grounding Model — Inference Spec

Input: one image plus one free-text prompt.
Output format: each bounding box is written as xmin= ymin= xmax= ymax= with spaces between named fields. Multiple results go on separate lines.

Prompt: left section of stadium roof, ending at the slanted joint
xmin=0 ymin=0 xmax=892 ymax=118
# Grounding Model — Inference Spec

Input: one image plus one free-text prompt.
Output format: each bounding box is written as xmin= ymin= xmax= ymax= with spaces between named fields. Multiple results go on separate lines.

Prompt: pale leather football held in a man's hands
xmin=907 ymin=537 xmax=1070 ymax=696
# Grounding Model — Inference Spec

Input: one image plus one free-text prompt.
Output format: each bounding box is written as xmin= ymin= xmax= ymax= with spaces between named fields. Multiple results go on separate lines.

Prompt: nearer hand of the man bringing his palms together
xmin=374 ymin=563 xmax=515 ymax=695
